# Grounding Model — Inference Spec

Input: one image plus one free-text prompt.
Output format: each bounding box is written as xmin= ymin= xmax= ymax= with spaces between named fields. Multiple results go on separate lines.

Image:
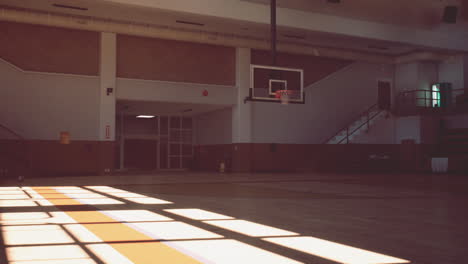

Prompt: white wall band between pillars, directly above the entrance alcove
xmin=116 ymin=78 xmax=236 ymax=106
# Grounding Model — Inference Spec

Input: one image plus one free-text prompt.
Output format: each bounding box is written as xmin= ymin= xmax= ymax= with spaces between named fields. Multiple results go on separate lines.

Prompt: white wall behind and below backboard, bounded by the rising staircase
xmin=250 ymin=62 xmax=394 ymax=144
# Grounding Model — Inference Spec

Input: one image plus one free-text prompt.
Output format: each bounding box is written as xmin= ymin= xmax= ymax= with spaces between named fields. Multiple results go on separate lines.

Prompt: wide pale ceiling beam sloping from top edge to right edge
xmin=104 ymin=0 xmax=468 ymax=52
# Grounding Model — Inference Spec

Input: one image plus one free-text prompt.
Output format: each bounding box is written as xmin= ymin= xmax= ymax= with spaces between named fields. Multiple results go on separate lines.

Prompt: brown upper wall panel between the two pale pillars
xmin=117 ymin=35 xmax=236 ymax=85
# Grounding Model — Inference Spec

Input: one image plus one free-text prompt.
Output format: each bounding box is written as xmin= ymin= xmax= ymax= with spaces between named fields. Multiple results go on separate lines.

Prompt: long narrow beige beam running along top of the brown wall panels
xmin=0 ymin=8 xmax=454 ymax=64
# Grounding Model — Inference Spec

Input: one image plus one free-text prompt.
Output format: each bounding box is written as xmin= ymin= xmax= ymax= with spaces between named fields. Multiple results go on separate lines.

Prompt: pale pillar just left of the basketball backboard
xmin=232 ymin=48 xmax=253 ymax=172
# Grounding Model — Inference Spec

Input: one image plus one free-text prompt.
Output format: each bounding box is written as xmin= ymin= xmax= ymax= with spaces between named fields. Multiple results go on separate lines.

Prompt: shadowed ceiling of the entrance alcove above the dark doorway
xmin=117 ymin=100 xmax=230 ymax=116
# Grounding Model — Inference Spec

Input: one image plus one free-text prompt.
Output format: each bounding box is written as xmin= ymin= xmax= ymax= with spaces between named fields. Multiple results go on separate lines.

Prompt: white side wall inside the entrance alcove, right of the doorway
xmin=194 ymin=108 xmax=232 ymax=145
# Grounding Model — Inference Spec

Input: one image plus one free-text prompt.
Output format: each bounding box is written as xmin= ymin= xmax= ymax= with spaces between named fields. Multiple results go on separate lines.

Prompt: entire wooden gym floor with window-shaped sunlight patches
xmin=0 ymin=172 xmax=468 ymax=264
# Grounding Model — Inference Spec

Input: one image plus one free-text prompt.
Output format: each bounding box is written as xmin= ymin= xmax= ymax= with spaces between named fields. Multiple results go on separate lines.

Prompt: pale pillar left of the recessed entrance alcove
xmin=98 ymin=32 xmax=117 ymax=173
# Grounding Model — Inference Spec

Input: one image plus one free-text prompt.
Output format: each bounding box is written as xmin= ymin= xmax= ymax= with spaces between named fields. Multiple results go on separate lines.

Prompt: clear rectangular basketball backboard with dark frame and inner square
xmin=246 ymin=64 xmax=304 ymax=104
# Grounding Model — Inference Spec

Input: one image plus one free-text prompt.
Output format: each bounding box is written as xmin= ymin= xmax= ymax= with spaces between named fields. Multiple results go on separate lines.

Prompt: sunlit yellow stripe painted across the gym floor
xmin=32 ymin=187 xmax=201 ymax=264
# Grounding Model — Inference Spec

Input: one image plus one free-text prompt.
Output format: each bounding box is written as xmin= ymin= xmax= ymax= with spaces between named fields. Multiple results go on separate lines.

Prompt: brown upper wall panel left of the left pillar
xmin=0 ymin=22 xmax=100 ymax=76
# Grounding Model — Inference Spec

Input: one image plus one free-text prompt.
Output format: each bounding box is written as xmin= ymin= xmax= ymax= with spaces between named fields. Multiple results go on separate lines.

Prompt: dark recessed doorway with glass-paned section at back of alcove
xmin=117 ymin=114 xmax=193 ymax=170
